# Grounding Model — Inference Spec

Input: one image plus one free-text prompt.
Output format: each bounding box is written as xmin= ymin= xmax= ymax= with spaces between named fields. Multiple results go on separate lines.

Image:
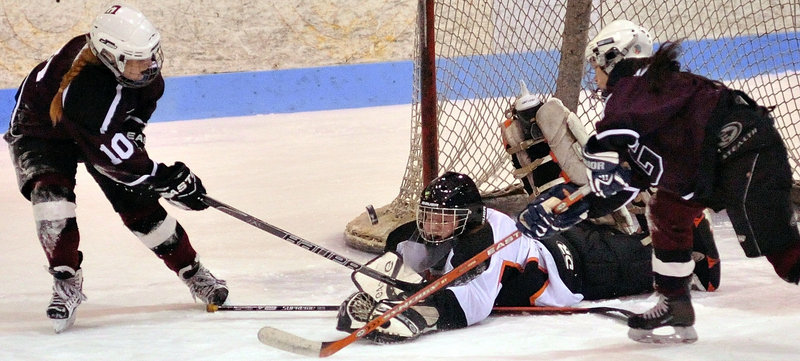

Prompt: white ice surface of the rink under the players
xmin=0 ymin=105 xmax=800 ymax=361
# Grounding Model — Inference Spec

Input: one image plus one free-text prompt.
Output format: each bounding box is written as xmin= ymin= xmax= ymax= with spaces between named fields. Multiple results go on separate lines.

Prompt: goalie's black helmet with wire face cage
xmin=417 ymin=172 xmax=485 ymax=244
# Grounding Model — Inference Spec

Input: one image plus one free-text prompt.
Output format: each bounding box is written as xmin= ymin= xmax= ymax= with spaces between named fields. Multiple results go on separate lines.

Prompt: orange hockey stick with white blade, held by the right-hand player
xmin=258 ymin=185 xmax=589 ymax=357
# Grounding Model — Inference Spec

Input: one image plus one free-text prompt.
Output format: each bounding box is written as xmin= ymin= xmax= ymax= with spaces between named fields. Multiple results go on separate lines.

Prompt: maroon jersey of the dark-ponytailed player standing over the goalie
xmin=597 ymin=68 xmax=723 ymax=198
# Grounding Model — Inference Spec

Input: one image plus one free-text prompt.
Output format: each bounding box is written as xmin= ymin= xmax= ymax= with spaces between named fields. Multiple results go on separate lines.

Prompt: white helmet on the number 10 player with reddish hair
xmin=87 ymin=5 xmax=163 ymax=88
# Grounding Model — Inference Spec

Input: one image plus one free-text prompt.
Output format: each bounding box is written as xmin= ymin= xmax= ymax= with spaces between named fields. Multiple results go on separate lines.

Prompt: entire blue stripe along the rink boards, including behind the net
xmin=0 ymin=32 xmax=800 ymax=132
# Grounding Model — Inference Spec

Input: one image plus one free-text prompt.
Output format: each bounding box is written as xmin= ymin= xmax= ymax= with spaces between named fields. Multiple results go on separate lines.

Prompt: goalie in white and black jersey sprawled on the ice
xmin=336 ymin=172 xmax=719 ymax=343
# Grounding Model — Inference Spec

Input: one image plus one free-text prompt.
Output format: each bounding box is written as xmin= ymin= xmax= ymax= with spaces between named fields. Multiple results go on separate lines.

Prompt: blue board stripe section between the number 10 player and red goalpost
xmin=151 ymin=61 xmax=413 ymax=121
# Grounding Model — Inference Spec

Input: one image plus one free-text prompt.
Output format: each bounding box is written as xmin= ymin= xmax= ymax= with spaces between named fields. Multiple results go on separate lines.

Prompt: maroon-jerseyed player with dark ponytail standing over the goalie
xmin=584 ymin=20 xmax=800 ymax=342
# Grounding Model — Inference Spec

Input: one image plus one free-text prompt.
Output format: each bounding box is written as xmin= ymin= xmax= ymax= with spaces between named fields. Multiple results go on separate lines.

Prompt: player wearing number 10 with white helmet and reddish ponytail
xmin=4 ymin=5 xmax=228 ymax=332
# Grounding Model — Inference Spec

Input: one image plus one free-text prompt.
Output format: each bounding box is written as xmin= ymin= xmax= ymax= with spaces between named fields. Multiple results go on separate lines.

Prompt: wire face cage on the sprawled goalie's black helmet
xmin=417 ymin=204 xmax=472 ymax=244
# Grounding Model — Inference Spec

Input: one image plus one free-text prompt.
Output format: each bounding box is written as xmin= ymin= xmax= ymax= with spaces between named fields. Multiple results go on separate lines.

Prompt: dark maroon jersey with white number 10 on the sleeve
xmin=10 ymin=35 xmax=164 ymax=186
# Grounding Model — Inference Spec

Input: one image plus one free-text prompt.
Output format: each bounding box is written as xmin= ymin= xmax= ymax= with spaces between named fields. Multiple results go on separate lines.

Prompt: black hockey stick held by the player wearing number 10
xmin=201 ymin=195 xmax=423 ymax=292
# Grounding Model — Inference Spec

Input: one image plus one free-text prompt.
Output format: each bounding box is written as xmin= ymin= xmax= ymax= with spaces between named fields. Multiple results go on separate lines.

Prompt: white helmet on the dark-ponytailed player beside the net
xmin=584 ymin=20 xmax=653 ymax=74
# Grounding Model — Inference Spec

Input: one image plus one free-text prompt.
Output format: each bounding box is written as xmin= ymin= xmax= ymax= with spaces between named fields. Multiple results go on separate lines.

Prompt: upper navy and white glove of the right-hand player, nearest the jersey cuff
xmin=583 ymin=144 xmax=631 ymax=198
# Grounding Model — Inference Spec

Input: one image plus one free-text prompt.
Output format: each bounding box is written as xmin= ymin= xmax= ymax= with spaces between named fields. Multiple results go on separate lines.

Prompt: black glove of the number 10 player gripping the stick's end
xmin=151 ymin=162 xmax=208 ymax=211
